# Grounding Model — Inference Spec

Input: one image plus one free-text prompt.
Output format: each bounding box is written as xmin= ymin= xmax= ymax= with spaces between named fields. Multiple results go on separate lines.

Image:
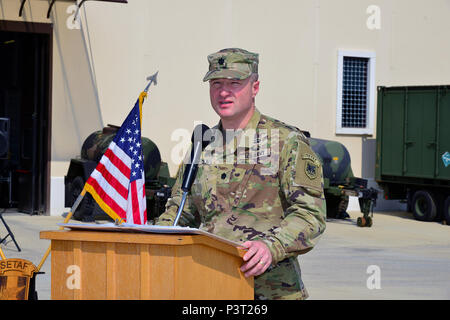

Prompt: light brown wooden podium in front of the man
xmin=40 ymin=230 xmax=254 ymax=300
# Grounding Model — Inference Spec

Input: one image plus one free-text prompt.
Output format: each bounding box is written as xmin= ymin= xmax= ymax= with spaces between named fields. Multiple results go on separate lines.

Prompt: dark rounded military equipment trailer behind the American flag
xmin=64 ymin=124 xmax=175 ymax=222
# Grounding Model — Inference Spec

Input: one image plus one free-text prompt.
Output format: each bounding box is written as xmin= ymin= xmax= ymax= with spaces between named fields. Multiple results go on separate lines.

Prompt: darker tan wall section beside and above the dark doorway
xmin=0 ymin=0 xmax=103 ymax=171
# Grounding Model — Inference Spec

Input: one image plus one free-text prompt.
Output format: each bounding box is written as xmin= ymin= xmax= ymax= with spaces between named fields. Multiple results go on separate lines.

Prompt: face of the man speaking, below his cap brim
xmin=209 ymin=77 xmax=259 ymax=126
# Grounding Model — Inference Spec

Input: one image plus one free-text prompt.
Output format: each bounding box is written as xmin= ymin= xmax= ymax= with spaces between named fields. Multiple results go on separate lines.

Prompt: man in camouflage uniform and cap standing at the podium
xmin=158 ymin=48 xmax=326 ymax=299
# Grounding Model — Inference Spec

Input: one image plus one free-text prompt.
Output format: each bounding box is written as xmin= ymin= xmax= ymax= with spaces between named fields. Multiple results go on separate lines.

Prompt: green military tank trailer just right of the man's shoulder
xmin=305 ymin=136 xmax=378 ymax=227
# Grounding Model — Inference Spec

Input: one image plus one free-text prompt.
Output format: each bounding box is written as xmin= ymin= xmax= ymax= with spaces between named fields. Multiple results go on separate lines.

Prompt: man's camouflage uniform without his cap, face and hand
xmin=158 ymin=109 xmax=326 ymax=299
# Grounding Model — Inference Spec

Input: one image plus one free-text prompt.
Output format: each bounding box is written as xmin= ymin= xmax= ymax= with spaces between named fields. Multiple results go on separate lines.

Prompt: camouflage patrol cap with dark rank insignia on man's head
xmin=203 ymin=48 xmax=258 ymax=81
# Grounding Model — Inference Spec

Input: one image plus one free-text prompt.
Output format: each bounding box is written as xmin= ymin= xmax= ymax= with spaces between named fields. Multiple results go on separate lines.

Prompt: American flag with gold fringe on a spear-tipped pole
xmin=85 ymin=99 xmax=147 ymax=224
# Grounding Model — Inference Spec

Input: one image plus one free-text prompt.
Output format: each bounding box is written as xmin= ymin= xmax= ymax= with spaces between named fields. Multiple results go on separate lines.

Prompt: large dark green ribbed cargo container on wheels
xmin=375 ymin=86 xmax=450 ymax=224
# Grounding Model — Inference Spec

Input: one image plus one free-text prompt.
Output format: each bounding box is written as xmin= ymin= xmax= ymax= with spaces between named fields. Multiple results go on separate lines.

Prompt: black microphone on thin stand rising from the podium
xmin=173 ymin=124 xmax=212 ymax=226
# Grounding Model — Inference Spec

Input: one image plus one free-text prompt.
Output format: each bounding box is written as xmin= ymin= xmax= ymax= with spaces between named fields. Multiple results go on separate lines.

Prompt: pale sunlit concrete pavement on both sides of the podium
xmin=0 ymin=210 xmax=450 ymax=300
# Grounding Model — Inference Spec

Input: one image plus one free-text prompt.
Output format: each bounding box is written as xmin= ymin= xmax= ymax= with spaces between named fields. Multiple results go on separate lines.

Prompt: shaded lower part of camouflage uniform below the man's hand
xmin=255 ymin=257 xmax=309 ymax=300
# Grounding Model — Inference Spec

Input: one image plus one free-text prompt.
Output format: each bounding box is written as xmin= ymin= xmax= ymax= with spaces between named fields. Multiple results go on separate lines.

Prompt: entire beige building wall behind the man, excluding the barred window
xmin=0 ymin=0 xmax=450 ymax=215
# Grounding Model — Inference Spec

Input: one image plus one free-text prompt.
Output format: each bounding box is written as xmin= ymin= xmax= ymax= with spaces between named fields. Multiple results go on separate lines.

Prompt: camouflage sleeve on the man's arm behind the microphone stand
xmin=155 ymin=163 xmax=198 ymax=227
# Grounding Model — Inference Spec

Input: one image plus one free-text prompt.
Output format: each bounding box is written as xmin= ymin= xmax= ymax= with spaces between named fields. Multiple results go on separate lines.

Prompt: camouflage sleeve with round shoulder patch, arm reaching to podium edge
xmin=262 ymin=135 xmax=326 ymax=265
